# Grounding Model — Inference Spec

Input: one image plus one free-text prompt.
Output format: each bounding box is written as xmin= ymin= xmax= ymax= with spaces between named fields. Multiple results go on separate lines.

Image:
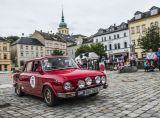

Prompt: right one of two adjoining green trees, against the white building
xmin=91 ymin=43 xmax=105 ymax=56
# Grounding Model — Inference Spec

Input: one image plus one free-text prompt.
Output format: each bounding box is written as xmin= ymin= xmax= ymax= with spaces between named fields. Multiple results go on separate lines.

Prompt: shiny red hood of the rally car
xmin=47 ymin=69 xmax=104 ymax=81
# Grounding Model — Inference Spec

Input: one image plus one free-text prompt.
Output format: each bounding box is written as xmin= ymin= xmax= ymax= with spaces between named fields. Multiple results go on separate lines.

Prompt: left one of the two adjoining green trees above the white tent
xmin=75 ymin=45 xmax=91 ymax=57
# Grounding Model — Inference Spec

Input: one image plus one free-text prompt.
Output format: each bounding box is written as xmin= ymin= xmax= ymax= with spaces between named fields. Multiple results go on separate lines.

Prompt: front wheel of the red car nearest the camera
xmin=43 ymin=86 xmax=58 ymax=107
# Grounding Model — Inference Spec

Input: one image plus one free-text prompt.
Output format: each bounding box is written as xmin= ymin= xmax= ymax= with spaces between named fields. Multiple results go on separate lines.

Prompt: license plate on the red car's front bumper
xmin=78 ymin=86 xmax=103 ymax=96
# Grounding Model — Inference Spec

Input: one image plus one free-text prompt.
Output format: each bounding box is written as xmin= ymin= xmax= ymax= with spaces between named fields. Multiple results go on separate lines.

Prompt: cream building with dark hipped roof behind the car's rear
xmin=11 ymin=37 xmax=45 ymax=67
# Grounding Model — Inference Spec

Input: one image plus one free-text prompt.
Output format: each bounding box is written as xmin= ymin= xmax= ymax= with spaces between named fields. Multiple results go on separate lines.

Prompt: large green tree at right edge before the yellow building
xmin=138 ymin=26 xmax=160 ymax=51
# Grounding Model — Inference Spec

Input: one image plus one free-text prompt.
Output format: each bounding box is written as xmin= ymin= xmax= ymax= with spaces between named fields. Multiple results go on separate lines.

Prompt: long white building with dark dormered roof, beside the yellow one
xmin=93 ymin=22 xmax=130 ymax=57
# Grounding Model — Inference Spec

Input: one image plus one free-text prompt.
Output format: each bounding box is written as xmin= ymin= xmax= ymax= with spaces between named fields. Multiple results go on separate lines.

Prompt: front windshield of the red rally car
xmin=42 ymin=57 xmax=78 ymax=71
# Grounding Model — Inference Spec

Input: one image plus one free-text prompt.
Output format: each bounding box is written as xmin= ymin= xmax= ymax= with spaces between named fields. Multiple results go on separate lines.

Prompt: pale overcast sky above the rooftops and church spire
xmin=0 ymin=0 xmax=160 ymax=36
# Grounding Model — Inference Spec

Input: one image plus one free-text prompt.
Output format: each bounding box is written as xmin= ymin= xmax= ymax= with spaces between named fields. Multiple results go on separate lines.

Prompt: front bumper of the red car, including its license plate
xmin=57 ymin=84 xmax=108 ymax=98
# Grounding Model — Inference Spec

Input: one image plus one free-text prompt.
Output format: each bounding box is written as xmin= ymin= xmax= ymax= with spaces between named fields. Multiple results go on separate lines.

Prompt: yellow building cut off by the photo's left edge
xmin=0 ymin=37 xmax=11 ymax=71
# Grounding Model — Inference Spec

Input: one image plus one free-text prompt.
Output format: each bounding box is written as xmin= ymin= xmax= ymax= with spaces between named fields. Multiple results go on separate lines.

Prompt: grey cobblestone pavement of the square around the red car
xmin=0 ymin=71 xmax=160 ymax=118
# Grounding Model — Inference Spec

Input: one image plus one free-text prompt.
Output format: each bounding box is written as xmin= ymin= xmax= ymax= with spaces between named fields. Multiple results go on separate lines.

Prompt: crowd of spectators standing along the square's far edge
xmin=77 ymin=48 xmax=160 ymax=70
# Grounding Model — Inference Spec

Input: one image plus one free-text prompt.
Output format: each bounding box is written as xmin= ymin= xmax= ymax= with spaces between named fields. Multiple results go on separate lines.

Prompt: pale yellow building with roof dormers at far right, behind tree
xmin=128 ymin=6 xmax=160 ymax=58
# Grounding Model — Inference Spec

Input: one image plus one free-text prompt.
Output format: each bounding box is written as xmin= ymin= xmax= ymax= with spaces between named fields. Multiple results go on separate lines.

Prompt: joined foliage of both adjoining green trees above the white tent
xmin=75 ymin=43 xmax=105 ymax=56
